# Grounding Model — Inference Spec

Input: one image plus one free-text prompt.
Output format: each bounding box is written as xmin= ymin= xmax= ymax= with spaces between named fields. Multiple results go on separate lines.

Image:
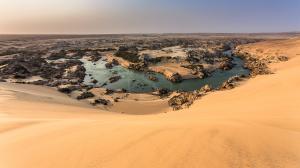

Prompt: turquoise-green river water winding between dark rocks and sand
xmin=82 ymin=57 xmax=250 ymax=93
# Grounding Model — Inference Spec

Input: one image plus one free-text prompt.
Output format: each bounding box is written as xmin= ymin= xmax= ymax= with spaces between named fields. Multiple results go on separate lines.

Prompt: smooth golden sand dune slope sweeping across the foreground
xmin=0 ymin=39 xmax=300 ymax=168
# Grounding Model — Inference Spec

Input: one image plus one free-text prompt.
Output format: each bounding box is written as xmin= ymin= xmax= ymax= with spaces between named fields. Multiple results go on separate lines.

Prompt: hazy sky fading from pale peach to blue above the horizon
xmin=0 ymin=0 xmax=300 ymax=34
